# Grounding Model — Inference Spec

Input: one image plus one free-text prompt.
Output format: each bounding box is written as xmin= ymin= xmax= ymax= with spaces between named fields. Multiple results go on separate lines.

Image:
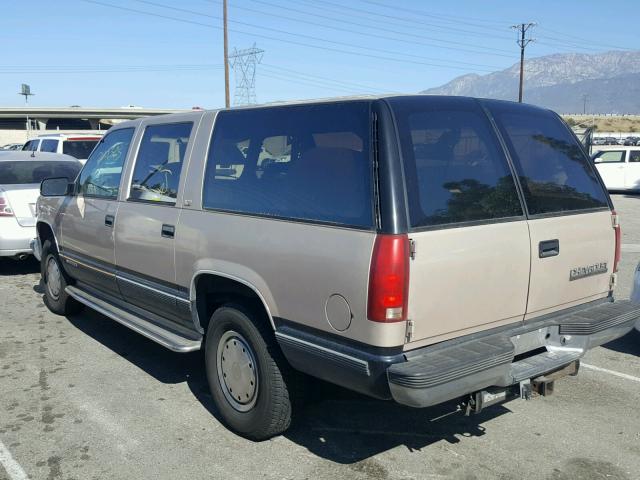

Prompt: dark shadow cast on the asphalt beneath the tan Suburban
xmin=67 ymin=309 xmax=510 ymax=464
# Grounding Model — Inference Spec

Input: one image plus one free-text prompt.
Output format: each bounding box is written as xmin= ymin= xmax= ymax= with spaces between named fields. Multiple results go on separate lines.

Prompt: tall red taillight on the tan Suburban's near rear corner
xmin=367 ymin=235 xmax=409 ymax=322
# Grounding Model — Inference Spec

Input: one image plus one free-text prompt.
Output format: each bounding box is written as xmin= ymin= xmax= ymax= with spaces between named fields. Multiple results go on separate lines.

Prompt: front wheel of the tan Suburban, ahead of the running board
xmin=40 ymin=240 xmax=82 ymax=316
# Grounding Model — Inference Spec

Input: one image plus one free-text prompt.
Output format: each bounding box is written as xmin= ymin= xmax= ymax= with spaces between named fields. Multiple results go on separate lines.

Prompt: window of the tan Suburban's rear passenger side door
xmin=129 ymin=122 xmax=192 ymax=204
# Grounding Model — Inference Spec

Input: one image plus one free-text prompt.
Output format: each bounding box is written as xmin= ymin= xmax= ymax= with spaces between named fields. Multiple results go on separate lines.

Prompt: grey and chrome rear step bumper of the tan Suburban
xmin=387 ymin=301 xmax=640 ymax=407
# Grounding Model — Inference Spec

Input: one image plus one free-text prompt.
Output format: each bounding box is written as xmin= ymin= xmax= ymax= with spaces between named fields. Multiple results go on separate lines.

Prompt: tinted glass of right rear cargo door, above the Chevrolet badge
xmin=489 ymin=103 xmax=608 ymax=215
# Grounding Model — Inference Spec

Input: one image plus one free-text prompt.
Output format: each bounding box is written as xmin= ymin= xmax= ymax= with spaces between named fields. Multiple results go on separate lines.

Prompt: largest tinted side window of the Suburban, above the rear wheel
xmin=203 ymin=102 xmax=374 ymax=228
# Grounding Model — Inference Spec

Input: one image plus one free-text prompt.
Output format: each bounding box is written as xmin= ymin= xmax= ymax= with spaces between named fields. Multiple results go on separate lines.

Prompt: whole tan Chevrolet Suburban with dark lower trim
xmin=34 ymin=96 xmax=640 ymax=439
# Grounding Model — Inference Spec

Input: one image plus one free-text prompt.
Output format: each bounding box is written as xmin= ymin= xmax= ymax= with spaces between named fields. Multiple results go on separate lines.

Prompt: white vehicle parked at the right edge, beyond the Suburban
xmin=591 ymin=146 xmax=640 ymax=191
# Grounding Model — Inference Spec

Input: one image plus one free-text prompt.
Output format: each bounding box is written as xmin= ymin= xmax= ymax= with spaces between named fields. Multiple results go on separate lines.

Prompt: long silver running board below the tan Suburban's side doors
xmin=65 ymin=286 xmax=202 ymax=353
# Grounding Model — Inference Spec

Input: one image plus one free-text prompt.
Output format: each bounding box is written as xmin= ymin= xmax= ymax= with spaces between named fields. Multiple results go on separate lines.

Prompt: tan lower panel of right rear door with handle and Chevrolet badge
xmin=527 ymin=211 xmax=615 ymax=318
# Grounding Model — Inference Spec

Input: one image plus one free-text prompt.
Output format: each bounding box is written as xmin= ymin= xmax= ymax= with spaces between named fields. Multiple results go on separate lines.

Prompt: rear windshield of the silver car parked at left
xmin=0 ymin=160 xmax=82 ymax=185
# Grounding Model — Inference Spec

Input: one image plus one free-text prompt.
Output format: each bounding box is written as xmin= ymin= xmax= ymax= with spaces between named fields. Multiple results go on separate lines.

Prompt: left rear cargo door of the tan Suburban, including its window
xmin=389 ymin=97 xmax=530 ymax=343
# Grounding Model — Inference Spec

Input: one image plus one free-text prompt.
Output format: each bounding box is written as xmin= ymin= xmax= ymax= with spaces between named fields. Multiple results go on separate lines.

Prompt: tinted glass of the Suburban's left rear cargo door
xmin=398 ymin=104 xmax=523 ymax=228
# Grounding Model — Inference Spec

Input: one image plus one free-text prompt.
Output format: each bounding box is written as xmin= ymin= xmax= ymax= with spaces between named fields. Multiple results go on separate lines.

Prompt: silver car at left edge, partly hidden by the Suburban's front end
xmin=0 ymin=151 xmax=82 ymax=258
